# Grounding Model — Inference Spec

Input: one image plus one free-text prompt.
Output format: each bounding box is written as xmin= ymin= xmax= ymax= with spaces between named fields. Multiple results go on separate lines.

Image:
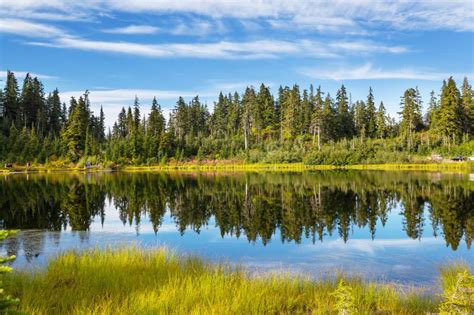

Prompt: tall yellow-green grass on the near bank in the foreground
xmin=2 ymin=248 xmax=470 ymax=314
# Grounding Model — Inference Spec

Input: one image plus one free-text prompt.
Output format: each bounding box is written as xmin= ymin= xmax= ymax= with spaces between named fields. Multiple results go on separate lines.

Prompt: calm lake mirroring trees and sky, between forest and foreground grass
xmin=0 ymin=171 xmax=474 ymax=287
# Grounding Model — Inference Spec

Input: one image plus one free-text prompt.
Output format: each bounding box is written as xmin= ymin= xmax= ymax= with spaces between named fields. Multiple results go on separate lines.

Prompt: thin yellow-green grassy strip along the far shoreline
xmin=0 ymin=161 xmax=474 ymax=174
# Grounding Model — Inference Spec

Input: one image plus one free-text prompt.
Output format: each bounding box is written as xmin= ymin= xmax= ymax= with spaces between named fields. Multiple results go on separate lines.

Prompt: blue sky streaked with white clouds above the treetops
xmin=0 ymin=0 xmax=474 ymax=125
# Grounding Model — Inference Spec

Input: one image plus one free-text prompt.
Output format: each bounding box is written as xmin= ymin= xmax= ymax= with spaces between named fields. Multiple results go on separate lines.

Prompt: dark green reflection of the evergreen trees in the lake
xmin=0 ymin=172 xmax=474 ymax=250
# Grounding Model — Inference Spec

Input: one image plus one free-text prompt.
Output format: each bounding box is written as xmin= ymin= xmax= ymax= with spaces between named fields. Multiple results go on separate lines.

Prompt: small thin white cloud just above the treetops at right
xmin=299 ymin=63 xmax=461 ymax=81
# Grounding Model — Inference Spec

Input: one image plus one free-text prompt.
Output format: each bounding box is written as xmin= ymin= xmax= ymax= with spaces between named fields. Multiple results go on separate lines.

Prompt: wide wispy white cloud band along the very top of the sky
xmin=0 ymin=0 xmax=474 ymax=31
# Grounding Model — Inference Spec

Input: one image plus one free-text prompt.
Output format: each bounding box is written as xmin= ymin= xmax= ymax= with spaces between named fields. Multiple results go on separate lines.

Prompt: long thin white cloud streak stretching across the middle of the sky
xmin=25 ymin=36 xmax=408 ymax=59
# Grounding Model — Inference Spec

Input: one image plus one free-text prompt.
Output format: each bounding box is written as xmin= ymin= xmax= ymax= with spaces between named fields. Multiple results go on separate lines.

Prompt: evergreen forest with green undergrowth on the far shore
xmin=0 ymin=71 xmax=474 ymax=166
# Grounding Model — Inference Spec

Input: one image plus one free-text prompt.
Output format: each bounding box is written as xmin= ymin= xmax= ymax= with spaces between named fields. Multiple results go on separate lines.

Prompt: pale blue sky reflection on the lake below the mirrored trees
xmin=0 ymin=200 xmax=474 ymax=285
